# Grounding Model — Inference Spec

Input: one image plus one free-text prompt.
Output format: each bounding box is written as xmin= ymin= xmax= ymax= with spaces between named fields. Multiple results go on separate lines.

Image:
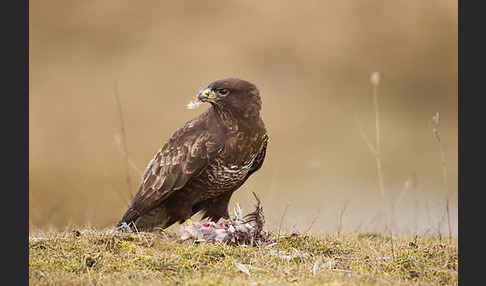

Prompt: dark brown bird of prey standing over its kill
xmin=118 ymin=78 xmax=268 ymax=231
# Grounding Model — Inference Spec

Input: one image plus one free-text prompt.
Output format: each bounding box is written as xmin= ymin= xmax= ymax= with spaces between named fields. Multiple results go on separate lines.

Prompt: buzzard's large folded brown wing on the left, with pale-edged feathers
xmin=121 ymin=117 xmax=224 ymax=223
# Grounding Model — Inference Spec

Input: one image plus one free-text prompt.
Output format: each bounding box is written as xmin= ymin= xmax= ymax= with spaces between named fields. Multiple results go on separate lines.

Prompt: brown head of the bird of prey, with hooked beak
xmin=198 ymin=78 xmax=262 ymax=117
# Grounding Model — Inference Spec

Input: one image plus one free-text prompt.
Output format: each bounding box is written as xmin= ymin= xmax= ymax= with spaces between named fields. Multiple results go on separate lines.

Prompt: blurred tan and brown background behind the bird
xmin=29 ymin=0 xmax=458 ymax=235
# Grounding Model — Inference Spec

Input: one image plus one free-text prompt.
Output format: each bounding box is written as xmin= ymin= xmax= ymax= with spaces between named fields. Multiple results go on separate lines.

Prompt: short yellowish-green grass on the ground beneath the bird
xmin=29 ymin=227 xmax=458 ymax=285
